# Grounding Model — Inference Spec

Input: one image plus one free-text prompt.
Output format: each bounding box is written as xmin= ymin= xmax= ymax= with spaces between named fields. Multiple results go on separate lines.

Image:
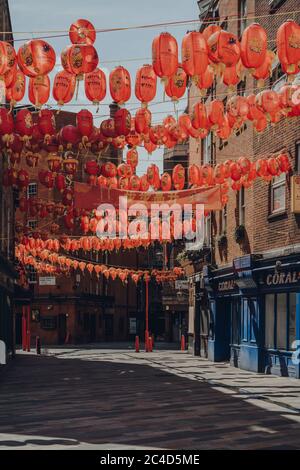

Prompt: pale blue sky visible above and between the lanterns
xmin=9 ymin=0 xmax=199 ymax=174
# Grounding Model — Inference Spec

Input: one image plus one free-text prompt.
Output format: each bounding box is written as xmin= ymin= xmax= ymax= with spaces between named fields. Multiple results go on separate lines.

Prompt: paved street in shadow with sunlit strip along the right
xmin=0 ymin=348 xmax=300 ymax=449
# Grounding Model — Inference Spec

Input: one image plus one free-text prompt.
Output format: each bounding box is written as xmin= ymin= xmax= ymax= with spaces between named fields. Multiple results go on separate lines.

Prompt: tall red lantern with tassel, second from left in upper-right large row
xmin=181 ymin=31 xmax=208 ymax=83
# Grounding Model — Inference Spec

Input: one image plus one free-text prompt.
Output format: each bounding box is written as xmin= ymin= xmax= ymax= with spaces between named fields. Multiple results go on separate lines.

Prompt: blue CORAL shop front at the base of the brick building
xmin=203 ymin=254 xmax=300 ymax=378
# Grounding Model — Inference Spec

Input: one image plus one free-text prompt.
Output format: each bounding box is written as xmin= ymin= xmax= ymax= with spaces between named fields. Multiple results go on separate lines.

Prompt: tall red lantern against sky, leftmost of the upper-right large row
xmin=152 ymin=33 xmax=178 ymax=82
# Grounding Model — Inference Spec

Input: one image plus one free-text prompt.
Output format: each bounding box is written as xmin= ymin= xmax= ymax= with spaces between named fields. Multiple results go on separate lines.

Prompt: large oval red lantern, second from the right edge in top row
xmin=241 ymin=23 xmax=268 ymax=69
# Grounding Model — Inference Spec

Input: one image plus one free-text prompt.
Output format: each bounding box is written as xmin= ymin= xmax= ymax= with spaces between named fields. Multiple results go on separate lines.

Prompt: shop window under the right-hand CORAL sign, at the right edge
xmin=265 ymin=292 xmax=296 ymax=351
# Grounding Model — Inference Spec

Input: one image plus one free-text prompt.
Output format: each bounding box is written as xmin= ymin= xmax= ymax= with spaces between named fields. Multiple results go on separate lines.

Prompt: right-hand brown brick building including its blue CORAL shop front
xmin=185 ymin=0 xmax=300 ymax=377
